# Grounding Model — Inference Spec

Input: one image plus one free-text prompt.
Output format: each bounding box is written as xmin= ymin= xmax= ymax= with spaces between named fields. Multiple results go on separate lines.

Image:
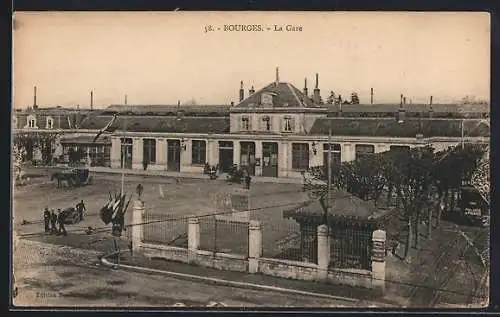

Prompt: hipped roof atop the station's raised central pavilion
xmin=235 ymin=82 xmax=317 ymax=108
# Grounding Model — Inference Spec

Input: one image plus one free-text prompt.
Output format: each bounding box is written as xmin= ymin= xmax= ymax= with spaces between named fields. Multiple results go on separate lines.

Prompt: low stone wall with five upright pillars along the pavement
xmin=132 ymin=201 xmax=386 ymax=292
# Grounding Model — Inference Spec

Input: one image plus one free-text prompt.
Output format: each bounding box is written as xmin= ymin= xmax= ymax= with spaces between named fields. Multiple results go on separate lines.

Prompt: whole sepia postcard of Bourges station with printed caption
xmin=10 ymin=10 xmax=491 ymax=311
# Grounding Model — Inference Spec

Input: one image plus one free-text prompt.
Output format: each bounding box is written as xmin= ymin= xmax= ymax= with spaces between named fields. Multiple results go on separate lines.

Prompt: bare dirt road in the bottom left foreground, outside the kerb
xmin=14 ymin=239 xmax=356 ymax=307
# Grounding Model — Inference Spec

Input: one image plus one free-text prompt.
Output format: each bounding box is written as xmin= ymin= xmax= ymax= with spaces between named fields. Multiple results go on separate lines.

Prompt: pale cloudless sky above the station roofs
xmin=12 ymin=11 xmax=490 ymax=108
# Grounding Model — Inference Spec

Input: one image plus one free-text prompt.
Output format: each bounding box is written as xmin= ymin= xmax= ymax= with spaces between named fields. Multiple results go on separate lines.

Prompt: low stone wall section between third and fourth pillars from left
xmin=259 ymin=258 xmax=318 ymax=281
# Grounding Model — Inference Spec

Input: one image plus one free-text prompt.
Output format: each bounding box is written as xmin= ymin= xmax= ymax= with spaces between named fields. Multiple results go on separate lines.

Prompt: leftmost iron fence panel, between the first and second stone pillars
xmin=142 ymin=211 xmax=189 ymax=248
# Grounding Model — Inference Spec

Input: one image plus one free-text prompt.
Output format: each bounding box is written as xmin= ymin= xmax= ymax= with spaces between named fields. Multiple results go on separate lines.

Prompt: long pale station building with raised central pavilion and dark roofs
xmin=13 ymin=75 xmax=490 ymax=177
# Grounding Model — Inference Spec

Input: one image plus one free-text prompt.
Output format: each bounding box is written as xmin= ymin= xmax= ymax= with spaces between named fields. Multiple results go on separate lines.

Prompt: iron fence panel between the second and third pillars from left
xmin=199 ymin=215 xmax=248 ymax=256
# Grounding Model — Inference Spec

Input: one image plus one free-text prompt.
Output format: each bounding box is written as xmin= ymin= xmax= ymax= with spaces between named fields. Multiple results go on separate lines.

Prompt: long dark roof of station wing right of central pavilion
xmin=309 ymin=118 xmax=490 ymax=137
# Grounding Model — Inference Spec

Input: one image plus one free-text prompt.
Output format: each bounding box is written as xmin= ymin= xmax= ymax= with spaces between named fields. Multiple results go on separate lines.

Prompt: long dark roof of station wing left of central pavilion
xmin=80 ymin=115 xmax=229 ymax=133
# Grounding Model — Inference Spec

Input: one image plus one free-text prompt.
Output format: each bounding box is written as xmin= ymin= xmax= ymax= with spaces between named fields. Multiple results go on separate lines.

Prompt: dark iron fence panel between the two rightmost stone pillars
xmin=330 ymin=227 xmax=372 ymax=270
